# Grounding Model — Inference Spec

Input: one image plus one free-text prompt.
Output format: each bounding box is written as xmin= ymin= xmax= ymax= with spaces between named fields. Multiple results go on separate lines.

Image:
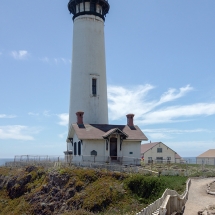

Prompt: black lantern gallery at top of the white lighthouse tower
xmin=68 ymin=0 xmax=110 ymax=20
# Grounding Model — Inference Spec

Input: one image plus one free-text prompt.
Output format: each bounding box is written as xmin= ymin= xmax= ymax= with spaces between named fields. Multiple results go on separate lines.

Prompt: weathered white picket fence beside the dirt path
xmin=136 ymin=179 xmax=191 ymax=215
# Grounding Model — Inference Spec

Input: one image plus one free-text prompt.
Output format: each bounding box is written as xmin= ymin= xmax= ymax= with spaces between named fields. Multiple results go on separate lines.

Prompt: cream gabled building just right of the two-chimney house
xmin=141 ymin=142 xmax=181 ymax=164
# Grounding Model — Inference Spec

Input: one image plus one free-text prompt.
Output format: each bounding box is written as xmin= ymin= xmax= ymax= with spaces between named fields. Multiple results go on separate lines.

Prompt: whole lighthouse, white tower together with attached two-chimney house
xmin=64 ymin=0 xmax=147 ymax=165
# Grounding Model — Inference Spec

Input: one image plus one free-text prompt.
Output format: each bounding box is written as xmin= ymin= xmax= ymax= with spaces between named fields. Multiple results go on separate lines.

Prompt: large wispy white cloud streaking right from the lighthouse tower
xmin=108 ymin=84 xmax=215 ymax=125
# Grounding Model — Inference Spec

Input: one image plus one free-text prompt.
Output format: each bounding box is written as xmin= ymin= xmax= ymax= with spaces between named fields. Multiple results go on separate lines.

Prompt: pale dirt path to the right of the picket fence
xmin=183 ymin=178 xmax=215 ymax=215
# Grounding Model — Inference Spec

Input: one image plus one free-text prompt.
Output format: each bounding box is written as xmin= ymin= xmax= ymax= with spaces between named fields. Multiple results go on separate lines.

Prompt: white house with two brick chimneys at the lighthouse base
xmin=65 ymin=112 xmax=148 ymax=165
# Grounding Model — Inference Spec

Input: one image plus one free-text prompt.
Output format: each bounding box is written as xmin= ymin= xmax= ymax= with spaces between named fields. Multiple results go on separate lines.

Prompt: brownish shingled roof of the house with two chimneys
xmin=67 ymin=124 xmax=148 ymax=141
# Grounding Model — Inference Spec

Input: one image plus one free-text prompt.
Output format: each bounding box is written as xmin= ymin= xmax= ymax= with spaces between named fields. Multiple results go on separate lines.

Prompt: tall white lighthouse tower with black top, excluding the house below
xmin=68 ymin=0 xmax=110 ymax=127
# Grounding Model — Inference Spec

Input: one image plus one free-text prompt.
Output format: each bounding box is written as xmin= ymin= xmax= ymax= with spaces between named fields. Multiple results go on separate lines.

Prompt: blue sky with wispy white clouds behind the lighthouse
xmin=0 ymin=0 xmax=215 ymax=158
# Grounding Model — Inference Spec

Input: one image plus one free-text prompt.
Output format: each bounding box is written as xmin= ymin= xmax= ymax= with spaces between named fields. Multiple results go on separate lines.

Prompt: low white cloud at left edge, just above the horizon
xmin=0 ymin=125 xmax=36 ymax=140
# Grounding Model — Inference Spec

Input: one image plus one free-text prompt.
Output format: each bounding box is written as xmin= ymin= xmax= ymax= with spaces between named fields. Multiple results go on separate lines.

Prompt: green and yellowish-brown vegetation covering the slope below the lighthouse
xmin=0 ymin=167 xmax=187 ymax=215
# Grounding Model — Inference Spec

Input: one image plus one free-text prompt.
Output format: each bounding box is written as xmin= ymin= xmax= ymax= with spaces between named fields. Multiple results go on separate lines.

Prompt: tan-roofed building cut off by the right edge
xmin=196 ymin=149 xmax=215 ymax=165
